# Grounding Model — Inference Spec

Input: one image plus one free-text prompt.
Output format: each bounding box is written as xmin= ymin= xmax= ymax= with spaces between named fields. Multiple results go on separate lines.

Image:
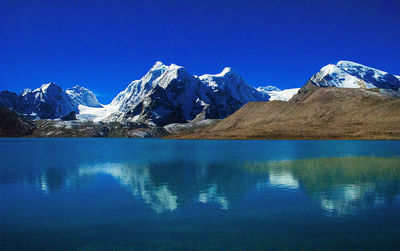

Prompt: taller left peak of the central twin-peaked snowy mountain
xmin=111 ymin=62 xmax=203 ymax=125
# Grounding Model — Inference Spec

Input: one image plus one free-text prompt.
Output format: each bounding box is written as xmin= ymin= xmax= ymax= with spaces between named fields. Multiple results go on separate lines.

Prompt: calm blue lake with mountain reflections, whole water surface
xmin=0 ymin=139 xmax=400 ymax=250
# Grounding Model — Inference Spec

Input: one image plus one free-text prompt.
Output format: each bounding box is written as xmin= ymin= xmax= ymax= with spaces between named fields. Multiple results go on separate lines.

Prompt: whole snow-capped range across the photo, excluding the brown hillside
xmin=0 ymin=61 xmax=400 ymax=138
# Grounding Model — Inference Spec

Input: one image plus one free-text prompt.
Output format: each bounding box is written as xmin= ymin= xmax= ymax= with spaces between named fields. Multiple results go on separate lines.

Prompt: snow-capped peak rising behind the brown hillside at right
xmin=310 ymin=61 xmax=400 ymax=91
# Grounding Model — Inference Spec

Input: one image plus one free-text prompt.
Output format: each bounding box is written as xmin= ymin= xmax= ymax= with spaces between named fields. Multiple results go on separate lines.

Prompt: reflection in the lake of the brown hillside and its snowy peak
xmin=246 ymin=157 xmax=400 ymax=216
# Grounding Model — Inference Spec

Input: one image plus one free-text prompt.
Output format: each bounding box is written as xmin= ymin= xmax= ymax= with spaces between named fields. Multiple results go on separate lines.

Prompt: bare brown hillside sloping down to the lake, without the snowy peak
xmin=176 ymin=85 xmax=400 ymax=139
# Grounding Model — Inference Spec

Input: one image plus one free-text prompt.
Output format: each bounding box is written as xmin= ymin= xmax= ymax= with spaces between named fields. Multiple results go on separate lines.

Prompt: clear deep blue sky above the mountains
xmin=0 ymin=0 xmax=400 ymax=103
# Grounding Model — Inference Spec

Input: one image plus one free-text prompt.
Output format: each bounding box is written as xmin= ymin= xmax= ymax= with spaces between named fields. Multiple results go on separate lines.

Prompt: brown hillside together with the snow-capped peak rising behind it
xmin=171 ymin=61 xmax=400 ymax=139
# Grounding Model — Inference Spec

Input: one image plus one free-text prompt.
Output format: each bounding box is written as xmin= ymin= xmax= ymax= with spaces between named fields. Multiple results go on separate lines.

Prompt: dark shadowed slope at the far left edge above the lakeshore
xmin=0 ymin=105 xmax=36 ymax=137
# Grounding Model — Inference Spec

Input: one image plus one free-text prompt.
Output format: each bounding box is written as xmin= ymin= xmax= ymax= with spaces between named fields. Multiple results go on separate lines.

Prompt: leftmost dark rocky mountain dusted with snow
xmin=0 ymin=83 xmax=78 ymax=119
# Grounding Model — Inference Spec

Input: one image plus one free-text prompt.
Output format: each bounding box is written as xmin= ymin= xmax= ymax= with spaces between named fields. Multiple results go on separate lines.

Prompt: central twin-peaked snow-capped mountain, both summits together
xmin=108 ymin=62 xmax=269 ymax=125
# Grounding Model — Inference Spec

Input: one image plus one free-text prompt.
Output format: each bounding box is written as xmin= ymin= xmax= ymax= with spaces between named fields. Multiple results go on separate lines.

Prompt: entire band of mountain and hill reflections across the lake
xmin=24 ymin=157 xmax=400 ymax=216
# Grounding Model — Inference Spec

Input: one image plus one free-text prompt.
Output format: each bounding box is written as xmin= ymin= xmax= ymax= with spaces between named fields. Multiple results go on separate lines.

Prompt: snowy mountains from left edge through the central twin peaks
xmin=0 ymin=62 xmax=282 ymax=126
